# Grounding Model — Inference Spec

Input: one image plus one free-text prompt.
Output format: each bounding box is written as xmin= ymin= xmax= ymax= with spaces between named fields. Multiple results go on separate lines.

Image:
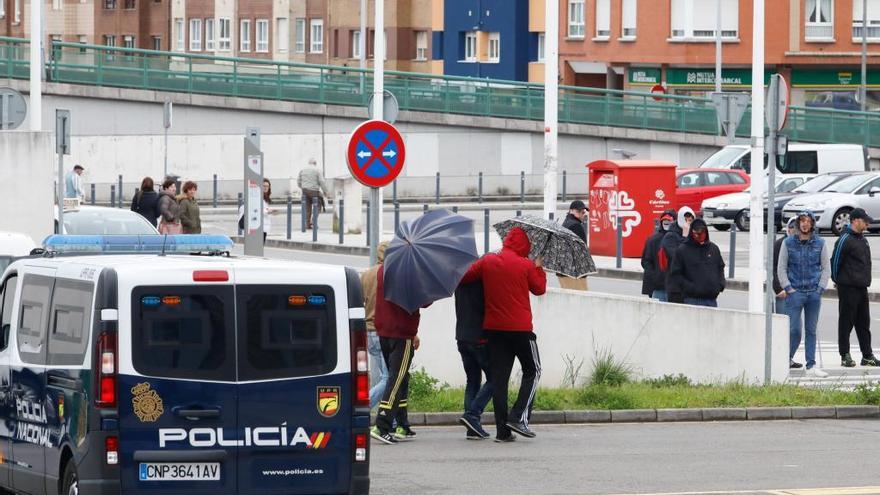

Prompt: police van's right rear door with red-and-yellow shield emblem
xmin=236 ymin=285 xmax=352 ymax=495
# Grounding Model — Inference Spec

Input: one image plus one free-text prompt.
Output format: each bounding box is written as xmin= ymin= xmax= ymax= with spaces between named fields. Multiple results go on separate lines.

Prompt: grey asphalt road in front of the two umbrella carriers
xmin=371 ymin=420 xmax=880 ymax=495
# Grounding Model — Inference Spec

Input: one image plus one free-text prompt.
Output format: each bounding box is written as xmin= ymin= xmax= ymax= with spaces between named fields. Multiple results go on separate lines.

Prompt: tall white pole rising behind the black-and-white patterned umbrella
xmin=544 ymin=0 xmax=559 ymax=218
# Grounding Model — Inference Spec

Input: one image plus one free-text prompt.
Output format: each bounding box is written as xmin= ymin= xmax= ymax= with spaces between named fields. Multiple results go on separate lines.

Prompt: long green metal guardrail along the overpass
xmin=0 ymin=37 xmax=880 ymax=147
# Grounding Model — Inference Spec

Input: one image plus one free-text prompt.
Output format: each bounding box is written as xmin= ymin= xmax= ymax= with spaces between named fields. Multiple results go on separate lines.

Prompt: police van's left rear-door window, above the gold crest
xmin=131 ymin=286 xmax=235 ymax=381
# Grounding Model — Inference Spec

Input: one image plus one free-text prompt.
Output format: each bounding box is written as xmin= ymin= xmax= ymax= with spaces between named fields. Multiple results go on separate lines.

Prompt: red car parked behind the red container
xmin=675 ymin=168 xmax=750 ymax=216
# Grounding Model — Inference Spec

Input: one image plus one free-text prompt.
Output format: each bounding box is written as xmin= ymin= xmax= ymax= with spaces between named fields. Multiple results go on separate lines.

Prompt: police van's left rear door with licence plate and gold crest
xmin=118 ymin=284 xmax=239 ymax=495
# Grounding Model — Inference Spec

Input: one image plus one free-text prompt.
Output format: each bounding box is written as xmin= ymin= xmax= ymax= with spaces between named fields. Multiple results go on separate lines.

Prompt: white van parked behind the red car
xmin=700 ymin=144 xmax=869 ymax=174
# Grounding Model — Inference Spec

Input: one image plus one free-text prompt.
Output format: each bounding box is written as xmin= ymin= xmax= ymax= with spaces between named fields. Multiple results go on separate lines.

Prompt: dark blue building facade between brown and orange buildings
xmin=444 ymin=0 xmax=532 ymax=81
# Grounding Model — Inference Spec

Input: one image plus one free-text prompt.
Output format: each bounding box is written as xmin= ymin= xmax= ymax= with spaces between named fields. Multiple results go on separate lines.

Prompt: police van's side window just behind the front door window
xmin=17 ymin=275 xmax=54 ymax=364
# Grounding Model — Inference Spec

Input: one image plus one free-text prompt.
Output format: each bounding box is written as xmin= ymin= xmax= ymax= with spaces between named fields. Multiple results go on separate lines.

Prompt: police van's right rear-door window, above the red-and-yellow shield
xmin=236 ymin=286 xmax=337 ymax=381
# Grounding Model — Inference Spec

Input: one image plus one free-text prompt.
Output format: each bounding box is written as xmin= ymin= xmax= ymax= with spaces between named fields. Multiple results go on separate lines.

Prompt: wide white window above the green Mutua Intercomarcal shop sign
xmin=672 ymin=0 xmax=739 ymax=40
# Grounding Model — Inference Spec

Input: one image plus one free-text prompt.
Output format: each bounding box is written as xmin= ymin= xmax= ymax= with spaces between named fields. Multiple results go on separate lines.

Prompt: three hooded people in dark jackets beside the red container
xmin=642 ymin=206 xmax=727 ymax=307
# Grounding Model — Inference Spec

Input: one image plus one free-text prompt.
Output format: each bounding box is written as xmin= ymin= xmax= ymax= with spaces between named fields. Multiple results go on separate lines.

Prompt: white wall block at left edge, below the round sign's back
xmin=0 ymin=131 xmax=57 ymax=244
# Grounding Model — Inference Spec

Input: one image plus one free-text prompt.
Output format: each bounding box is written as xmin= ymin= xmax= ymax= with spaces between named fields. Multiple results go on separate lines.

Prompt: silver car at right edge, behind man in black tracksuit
xmin=782 ymin=172 xmax=880 ymax=235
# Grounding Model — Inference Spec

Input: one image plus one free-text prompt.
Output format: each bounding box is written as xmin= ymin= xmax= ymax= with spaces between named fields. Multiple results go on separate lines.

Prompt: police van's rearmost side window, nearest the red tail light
xmin=49 ymin=280 xmax=94 ymax=365
